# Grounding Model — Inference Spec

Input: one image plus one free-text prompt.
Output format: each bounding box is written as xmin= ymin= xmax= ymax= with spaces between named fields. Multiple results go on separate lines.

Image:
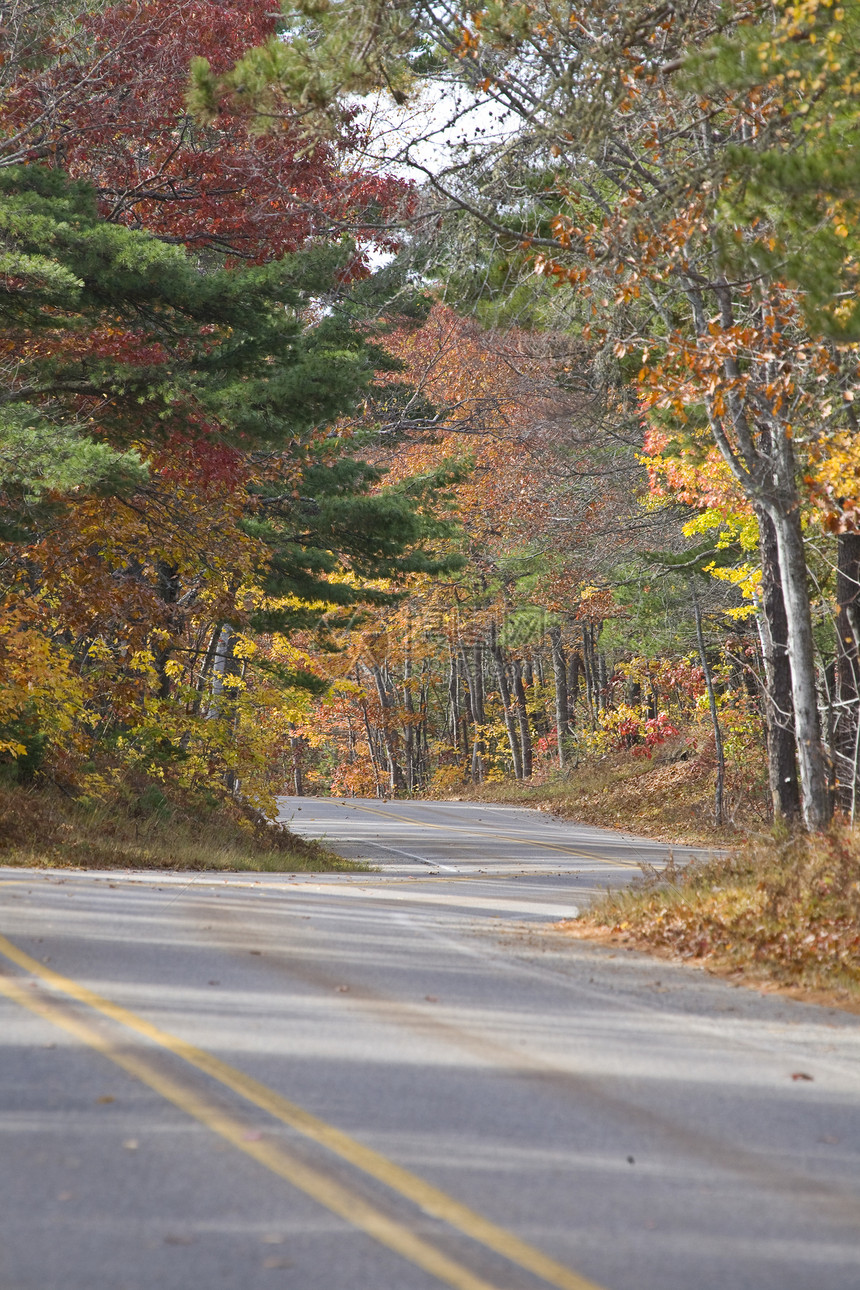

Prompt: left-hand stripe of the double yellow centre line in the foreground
xmin=0 ymin=977 xmax=499 ymax=1290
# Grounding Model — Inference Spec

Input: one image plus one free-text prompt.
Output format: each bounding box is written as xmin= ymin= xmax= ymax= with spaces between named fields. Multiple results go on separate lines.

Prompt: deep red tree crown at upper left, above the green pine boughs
xmin=0 ymin=0 xmax=410 ymax=261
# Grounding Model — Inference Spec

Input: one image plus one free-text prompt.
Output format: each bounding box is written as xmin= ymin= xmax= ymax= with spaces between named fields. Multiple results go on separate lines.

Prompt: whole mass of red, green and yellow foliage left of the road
xmin=0 ymin=3 xmax=432 ymax=810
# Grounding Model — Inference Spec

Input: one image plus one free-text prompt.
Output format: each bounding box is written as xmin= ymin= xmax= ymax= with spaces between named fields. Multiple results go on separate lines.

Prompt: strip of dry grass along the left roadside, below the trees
xmin=0 ymin=783 xmax=367 ymax=873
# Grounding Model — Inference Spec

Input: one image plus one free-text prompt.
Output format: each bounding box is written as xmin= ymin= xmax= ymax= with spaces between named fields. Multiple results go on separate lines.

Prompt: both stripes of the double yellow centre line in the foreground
xmin=0 ymin=937 xmax=601 ymax=1290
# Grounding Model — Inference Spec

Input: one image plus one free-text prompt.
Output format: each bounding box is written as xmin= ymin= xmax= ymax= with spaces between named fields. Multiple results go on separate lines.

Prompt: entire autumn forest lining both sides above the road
xmin=0 ymin=0 xmax=860 ymax=888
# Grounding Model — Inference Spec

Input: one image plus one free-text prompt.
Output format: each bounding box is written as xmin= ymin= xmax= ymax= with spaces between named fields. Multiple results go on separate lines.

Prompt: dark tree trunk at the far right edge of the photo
xmin=833 ymin=533 xmax=860 ymax=823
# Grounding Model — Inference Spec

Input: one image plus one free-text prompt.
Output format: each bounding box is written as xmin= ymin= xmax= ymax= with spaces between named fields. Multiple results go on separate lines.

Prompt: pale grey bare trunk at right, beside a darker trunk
xmin=771 ymin=507 xmax=830 ymax=832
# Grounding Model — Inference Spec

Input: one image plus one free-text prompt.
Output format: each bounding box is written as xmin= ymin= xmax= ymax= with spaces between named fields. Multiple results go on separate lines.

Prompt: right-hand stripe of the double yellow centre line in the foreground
xmin=0 ymin=937 xmax=601 ymax=1290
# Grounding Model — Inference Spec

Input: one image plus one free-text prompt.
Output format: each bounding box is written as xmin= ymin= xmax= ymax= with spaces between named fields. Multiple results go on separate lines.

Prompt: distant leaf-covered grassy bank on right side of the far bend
xmin=448 ymin=749 xmax=765 ymax=845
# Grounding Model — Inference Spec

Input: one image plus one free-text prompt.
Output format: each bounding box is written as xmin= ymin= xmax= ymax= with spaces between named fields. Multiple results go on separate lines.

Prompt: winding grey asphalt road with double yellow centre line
xmin=0 ymin=799 xmax=860 ymax=1290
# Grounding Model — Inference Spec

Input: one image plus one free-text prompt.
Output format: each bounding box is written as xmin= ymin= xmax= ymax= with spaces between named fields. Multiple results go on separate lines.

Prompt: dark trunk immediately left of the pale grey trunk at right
xmin=756 ymin=507 xmax=801 ymax=820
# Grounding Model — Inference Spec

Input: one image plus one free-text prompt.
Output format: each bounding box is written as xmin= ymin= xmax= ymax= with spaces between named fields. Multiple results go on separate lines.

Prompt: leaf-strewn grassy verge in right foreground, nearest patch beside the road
xmin=562 ymin=826 xmax=860 ymax=1010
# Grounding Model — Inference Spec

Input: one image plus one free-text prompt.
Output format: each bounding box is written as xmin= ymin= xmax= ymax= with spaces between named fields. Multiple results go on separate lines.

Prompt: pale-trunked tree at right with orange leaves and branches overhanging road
xmin=195 ymin=0 xmax=856 ymax=828
